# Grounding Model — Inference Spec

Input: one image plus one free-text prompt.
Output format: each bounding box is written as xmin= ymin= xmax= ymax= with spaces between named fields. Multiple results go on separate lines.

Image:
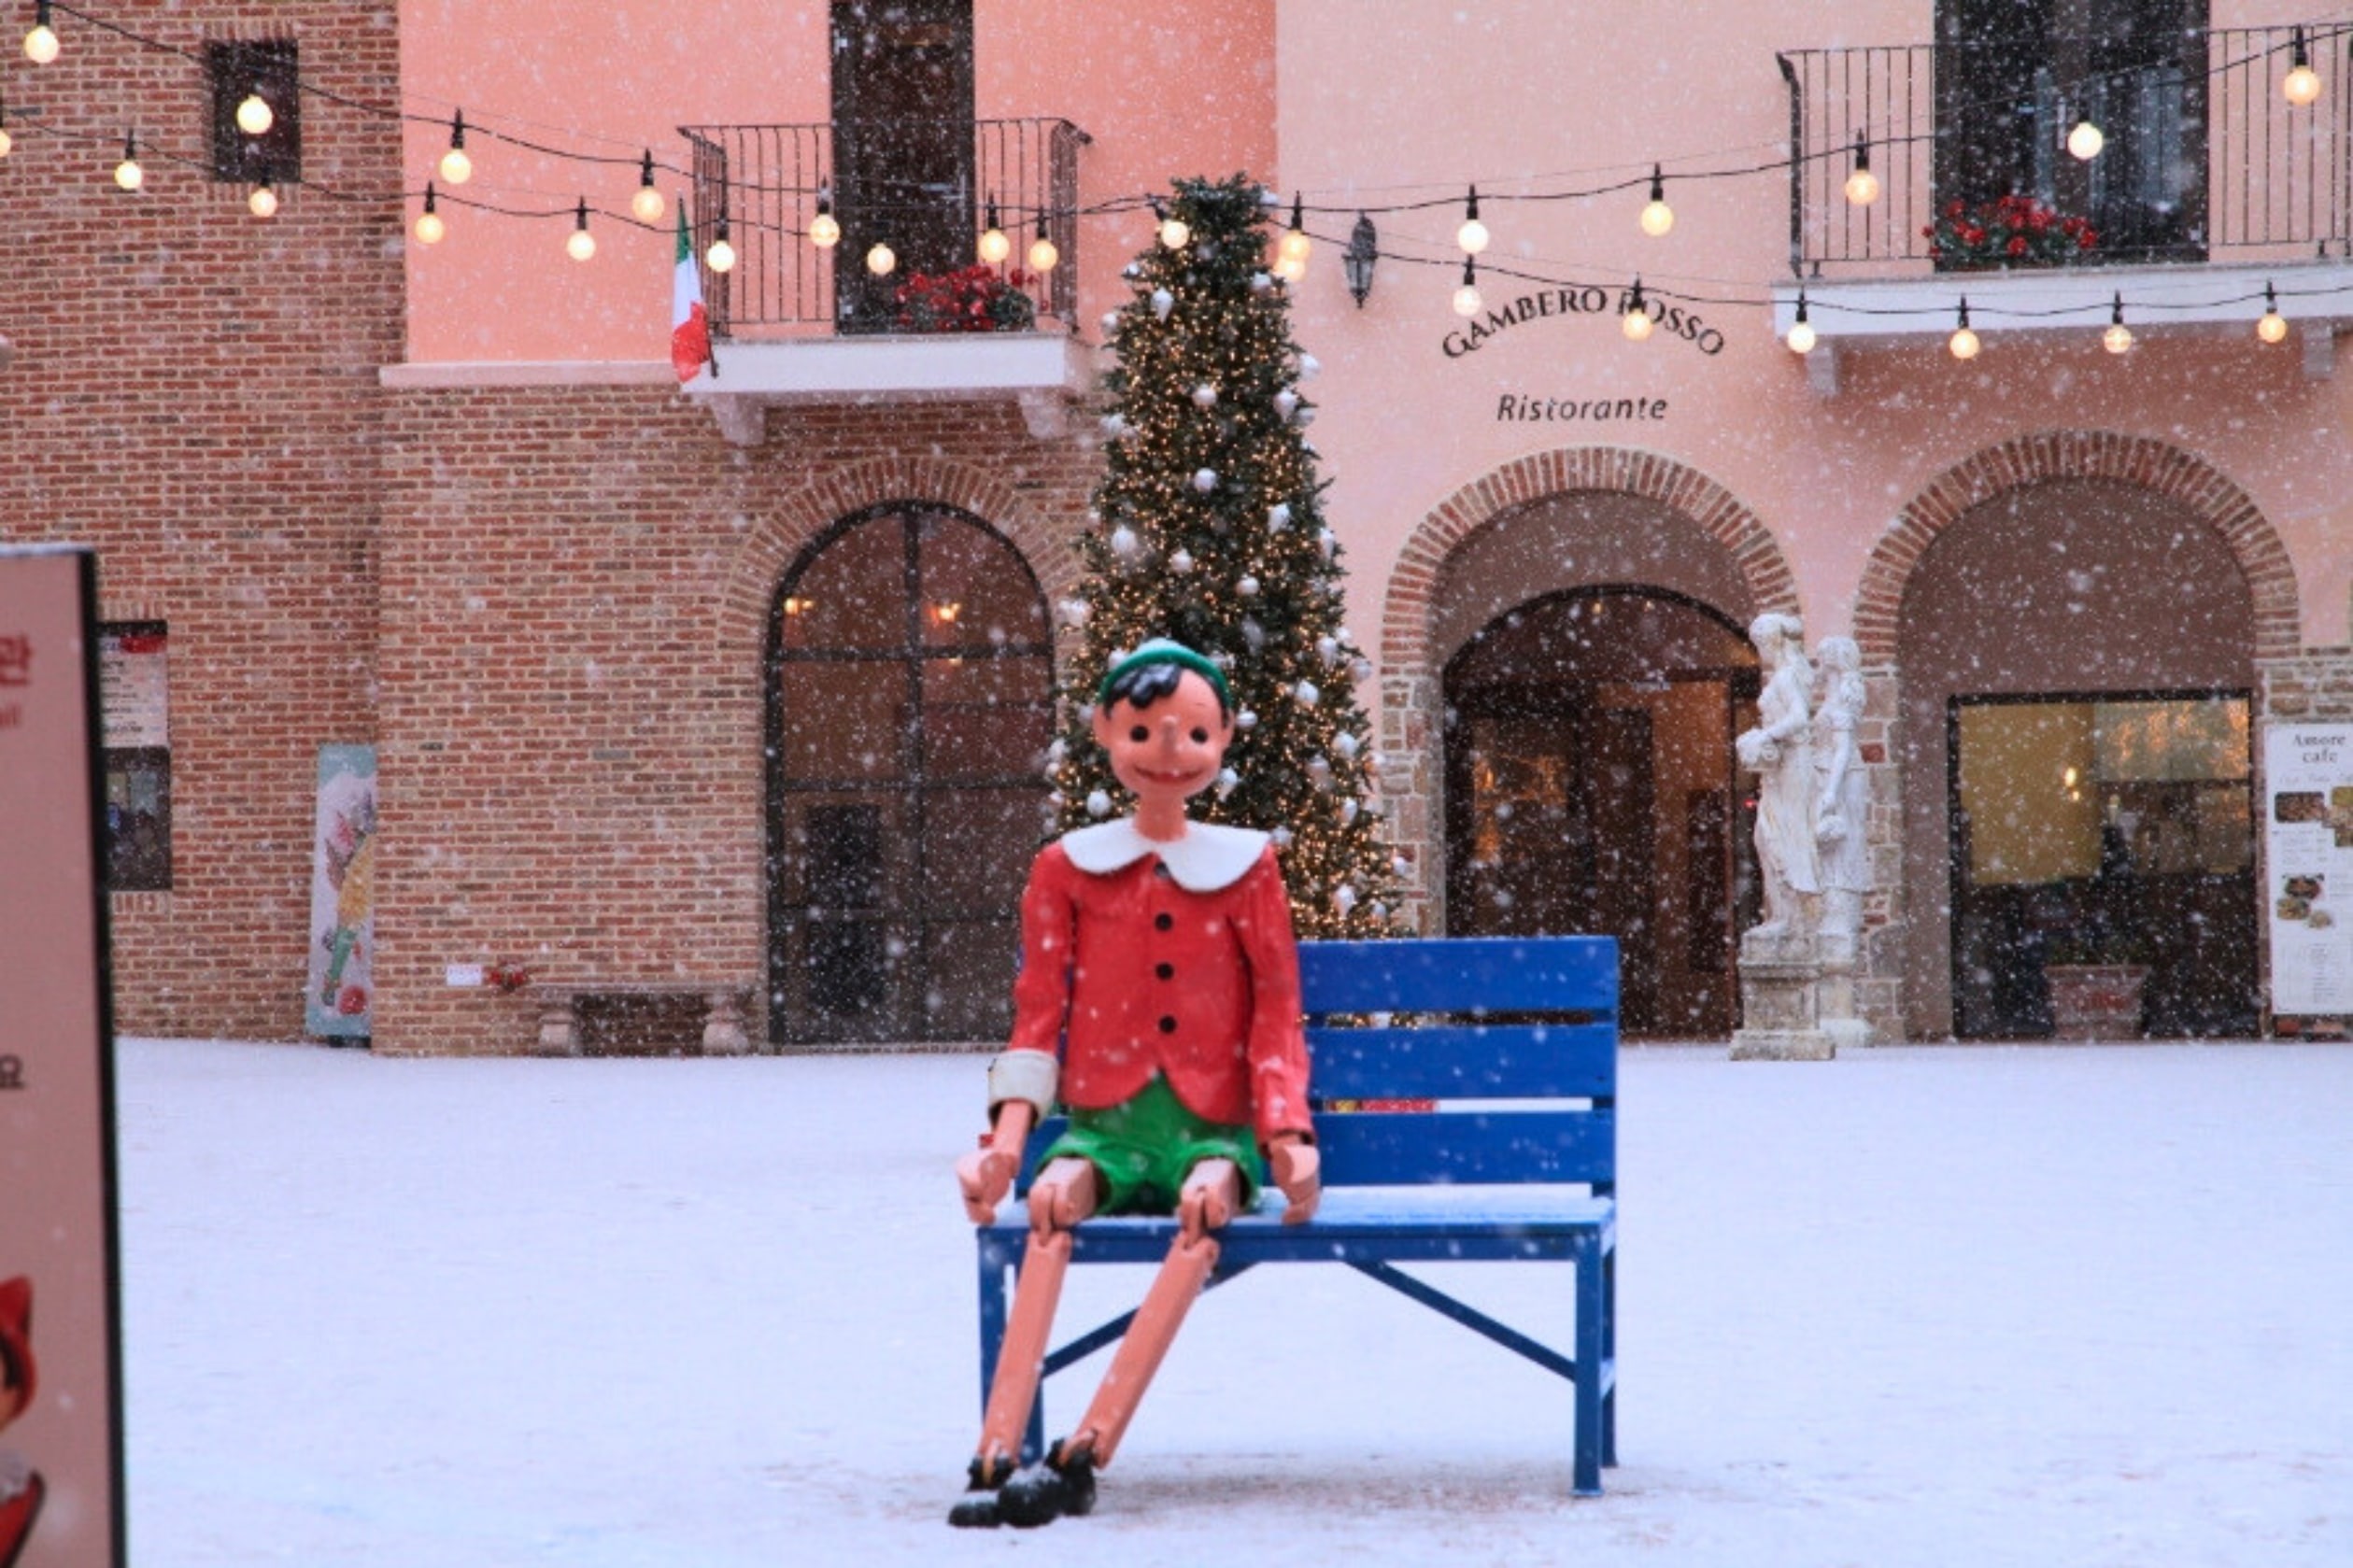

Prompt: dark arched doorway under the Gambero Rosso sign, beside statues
xmin=1442 ymin=586 xmax=1758 ymax=1039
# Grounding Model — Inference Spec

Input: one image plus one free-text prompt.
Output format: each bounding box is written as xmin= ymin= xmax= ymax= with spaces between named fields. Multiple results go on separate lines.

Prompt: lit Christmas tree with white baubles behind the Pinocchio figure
xmin=1052 ymin=177 xmax=1397 ymax=938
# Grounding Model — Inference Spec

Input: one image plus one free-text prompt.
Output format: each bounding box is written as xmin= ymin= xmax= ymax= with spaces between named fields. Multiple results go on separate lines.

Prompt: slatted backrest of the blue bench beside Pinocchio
xmin=1024 ymin=936 xmax=1619 ymax=1194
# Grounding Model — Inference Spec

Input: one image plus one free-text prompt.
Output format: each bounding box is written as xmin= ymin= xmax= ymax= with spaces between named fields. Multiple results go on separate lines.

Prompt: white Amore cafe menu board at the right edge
xmin=2263 ymin=722 xmax=2353 ymax=1020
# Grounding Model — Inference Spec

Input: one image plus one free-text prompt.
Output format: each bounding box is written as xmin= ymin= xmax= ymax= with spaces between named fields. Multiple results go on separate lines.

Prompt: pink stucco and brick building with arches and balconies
xmin=0 ymin=0 xmax=2353 ymax=1051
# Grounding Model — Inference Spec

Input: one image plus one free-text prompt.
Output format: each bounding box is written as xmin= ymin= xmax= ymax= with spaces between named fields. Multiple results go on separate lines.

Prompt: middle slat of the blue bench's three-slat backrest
xmin=1309 ymin=1023 xmax=1617 ymax=1100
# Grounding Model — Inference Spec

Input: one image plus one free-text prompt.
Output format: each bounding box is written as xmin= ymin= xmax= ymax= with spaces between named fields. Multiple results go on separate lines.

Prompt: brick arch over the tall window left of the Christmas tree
xmin=720 ymin=456 xmax=1078 ymax=672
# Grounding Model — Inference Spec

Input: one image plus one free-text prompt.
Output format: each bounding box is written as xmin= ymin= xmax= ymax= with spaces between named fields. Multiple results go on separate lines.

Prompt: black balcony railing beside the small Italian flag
xmin=680 ymin=120 xmax=1087 ymax=341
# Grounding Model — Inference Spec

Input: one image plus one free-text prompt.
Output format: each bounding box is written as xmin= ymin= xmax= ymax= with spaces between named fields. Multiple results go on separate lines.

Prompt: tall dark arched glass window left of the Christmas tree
xmin=765 ymin=503 xmax=1055 ymax=1044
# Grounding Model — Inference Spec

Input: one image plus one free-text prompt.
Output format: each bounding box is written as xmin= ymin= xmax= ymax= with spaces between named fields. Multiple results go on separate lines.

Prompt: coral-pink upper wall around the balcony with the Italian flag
xmin=400 ymin=0 xmax=1275 ymax=362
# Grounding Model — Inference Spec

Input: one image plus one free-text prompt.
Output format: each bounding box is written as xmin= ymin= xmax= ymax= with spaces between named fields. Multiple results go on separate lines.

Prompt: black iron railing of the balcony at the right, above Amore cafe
xmin=1779 ymin=21 xmax=2353 ymax=277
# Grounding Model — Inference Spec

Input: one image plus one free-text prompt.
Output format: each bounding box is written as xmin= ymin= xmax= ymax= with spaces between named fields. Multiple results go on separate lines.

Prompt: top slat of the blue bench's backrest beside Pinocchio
xmin=1298 ymin=936 xmax=1619 ymax=1018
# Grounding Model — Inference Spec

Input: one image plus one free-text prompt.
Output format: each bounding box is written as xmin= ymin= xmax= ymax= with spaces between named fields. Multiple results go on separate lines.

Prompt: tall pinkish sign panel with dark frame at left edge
xmin=0 ymin=548 xmax=125 ymax=1568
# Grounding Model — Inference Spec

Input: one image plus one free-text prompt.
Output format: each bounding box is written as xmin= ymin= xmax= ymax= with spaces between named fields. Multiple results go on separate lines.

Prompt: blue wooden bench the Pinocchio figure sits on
xmin=976 ymin=936 xmax=1619 ymax=1497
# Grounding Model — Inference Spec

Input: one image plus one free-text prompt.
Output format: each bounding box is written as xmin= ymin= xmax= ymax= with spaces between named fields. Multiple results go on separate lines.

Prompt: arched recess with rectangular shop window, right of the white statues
xmin=1896 ymin=477 xmax=2261 ymax=1039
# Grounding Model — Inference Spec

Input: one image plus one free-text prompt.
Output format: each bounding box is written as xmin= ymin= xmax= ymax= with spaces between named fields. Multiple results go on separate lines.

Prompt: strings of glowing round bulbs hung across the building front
xmin=13 ymin=0 xmax=2353 ymax=341
